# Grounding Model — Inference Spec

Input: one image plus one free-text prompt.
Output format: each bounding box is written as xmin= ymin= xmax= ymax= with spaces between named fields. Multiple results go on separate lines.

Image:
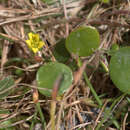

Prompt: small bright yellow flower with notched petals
xmin=26 ymin=33 xmax=45 ymax=53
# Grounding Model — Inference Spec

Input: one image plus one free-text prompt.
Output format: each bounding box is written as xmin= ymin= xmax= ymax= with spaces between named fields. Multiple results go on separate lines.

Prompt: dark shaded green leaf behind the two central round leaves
xmin=53 ymin=39 xmax=70 ymax=63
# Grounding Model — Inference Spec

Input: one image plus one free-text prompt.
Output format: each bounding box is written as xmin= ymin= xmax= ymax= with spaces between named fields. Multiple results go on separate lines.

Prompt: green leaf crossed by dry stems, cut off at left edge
xmin=0 ymin=76 xmax=14 ymax=99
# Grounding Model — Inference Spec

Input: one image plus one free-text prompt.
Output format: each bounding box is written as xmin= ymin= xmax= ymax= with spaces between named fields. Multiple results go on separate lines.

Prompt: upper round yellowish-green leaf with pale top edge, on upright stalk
xmin=66 ymin=26 xmax=100 ymax=56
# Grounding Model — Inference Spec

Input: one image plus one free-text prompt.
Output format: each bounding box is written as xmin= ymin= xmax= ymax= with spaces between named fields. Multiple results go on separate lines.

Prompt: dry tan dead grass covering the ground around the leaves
xmin=0 ymin=0 xmax=130 ymax=130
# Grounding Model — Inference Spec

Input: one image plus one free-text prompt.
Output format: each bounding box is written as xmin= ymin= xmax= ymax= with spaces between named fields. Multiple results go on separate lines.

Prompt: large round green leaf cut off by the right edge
xmin=110 ymin=47 xmax=130 ymax=94
